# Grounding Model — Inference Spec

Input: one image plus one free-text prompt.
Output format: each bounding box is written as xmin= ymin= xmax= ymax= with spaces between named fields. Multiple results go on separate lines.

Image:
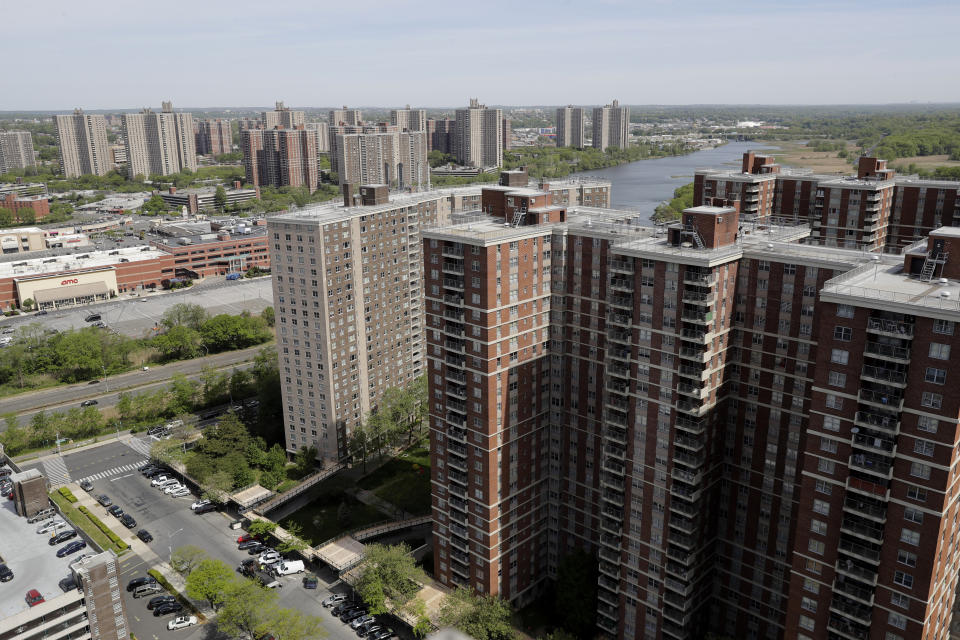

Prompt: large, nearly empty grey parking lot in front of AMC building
xmin=0 ymin=276 xmax=273 ymax=338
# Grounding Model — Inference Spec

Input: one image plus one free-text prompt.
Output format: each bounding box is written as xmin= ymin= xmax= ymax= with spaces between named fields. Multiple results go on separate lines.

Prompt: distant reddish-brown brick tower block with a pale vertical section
xmin=240 ymin=127 xmax=319 ymax=192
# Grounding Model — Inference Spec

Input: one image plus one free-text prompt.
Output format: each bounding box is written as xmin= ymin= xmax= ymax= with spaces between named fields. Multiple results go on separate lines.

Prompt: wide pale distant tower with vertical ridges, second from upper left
xmin=122 ymin=102 xmax=197 ymax=178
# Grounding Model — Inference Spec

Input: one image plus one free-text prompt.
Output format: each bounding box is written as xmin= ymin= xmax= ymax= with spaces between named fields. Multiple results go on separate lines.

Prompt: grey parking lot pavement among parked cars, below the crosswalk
xmin=76 ymin=460 xmax=403 ymax=640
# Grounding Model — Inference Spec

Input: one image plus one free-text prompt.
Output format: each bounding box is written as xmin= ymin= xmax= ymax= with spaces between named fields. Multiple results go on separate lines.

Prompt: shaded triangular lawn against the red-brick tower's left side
xmin=357 ymin=442 xmax=431 ymax=516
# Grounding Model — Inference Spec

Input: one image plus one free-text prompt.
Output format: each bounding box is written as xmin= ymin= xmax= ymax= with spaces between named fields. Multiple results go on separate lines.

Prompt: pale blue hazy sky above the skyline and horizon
xmin=0 ymin=0 xmax=960 ymax=110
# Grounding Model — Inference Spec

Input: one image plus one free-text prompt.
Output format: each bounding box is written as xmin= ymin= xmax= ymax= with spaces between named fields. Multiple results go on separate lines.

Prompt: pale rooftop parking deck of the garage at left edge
xmin=0 ymin=500 xmax=75 ymax=619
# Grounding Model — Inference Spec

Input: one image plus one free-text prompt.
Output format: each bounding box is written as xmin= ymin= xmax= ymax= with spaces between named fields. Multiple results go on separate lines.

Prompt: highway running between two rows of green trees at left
xmin=0 ymin=345 xmax=263 ymax=424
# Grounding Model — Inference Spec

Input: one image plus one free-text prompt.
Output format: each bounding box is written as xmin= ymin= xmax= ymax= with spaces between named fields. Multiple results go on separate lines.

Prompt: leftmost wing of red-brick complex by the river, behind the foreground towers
xmin=693 ymin=151 xmax=780 ymax=220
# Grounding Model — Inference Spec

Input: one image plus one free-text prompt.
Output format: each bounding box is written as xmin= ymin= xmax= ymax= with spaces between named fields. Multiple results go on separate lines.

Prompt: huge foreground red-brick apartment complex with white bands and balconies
xmin=424 ymin=166 xmax=960 ymax=640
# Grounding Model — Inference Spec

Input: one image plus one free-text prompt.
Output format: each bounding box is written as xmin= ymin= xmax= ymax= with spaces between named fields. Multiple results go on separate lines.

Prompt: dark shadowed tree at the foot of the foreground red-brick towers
xmin=554 ymin=551 xmax=599 ymax=638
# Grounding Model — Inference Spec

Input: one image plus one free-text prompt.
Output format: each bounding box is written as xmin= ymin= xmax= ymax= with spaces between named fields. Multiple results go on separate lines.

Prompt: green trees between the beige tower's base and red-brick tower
xmin=347 ymin=374 xmax=428 ymax=473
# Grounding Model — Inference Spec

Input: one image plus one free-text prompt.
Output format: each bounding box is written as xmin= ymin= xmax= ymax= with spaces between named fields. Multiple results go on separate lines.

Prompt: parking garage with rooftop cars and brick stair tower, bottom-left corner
xmin=0 ymin=498 xmax=130 ymax=640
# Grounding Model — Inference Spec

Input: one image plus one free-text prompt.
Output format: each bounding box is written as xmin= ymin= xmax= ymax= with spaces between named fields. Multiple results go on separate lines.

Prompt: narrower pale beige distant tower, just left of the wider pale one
xmin=53 ymin=109 xmax=113 ymax=178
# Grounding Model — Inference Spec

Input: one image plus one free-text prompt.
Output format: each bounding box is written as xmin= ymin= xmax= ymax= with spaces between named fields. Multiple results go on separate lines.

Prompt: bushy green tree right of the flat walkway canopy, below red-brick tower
xmin=355 ymin=544 xmax=426 ymax=615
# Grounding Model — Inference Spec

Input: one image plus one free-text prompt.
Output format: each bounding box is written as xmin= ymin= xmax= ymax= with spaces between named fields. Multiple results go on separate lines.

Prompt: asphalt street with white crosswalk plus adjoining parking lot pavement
xmin=32 ymin=438 xmax=406 ymax=640
